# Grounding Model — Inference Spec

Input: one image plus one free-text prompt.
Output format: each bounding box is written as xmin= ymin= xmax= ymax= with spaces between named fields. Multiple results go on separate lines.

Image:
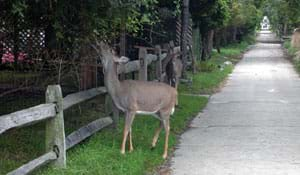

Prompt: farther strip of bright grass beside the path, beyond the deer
xmin=179 ymin=41 xmax=253 ymax=94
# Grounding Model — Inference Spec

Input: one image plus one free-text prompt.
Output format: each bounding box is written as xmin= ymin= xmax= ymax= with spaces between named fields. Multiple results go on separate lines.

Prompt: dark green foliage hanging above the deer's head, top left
xmin=0 ymin=0 xmax=172 ymax=52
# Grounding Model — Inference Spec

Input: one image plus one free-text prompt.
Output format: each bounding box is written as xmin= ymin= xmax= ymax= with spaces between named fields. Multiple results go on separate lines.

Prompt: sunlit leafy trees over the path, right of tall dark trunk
xmin=190 ymin=0 xmax=262 ymax=60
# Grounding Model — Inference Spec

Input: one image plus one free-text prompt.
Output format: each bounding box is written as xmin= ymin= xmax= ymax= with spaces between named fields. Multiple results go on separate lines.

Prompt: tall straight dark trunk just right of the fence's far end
xmin=180 ymin=0 xmax=189 ymax=77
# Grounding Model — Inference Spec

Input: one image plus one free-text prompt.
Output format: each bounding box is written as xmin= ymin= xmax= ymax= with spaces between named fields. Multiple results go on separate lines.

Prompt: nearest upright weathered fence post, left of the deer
xmin=46 ymin=85 xmax=66 ymax=168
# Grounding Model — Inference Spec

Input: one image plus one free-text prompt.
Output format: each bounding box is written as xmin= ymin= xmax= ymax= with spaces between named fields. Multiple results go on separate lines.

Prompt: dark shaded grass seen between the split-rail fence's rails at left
xmin=0 ymin=94 xmax=108 ymax=174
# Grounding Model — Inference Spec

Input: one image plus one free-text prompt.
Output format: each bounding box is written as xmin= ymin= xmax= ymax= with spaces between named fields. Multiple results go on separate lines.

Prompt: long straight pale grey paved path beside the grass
xmin=171 ymin=32 xmax=300 ymax=175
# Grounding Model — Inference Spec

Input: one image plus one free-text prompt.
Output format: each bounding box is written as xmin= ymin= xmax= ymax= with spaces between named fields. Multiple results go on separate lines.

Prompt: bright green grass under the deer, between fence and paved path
xmin=38 ymin=95 xmax=207 ymax=175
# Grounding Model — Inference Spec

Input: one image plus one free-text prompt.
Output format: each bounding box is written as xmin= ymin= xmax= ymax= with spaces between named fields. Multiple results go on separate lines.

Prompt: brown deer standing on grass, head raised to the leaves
xmin=93 ymin=41 xmax=177 ymax=159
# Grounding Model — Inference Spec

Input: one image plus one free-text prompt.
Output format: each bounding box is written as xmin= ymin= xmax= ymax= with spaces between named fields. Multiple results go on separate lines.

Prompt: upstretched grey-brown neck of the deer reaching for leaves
xmin=104 ymin=62 xmax=121 ymax=99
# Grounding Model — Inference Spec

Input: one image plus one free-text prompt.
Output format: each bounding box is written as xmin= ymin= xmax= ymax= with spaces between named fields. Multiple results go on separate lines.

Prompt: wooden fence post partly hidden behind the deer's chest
xmin=105 ymin=94 xmax=120 ymax=128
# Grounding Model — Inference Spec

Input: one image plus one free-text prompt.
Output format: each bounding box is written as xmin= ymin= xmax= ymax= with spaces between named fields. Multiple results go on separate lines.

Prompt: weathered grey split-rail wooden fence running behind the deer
xmin=0 ymin=44 xmax=180 ymax=175
